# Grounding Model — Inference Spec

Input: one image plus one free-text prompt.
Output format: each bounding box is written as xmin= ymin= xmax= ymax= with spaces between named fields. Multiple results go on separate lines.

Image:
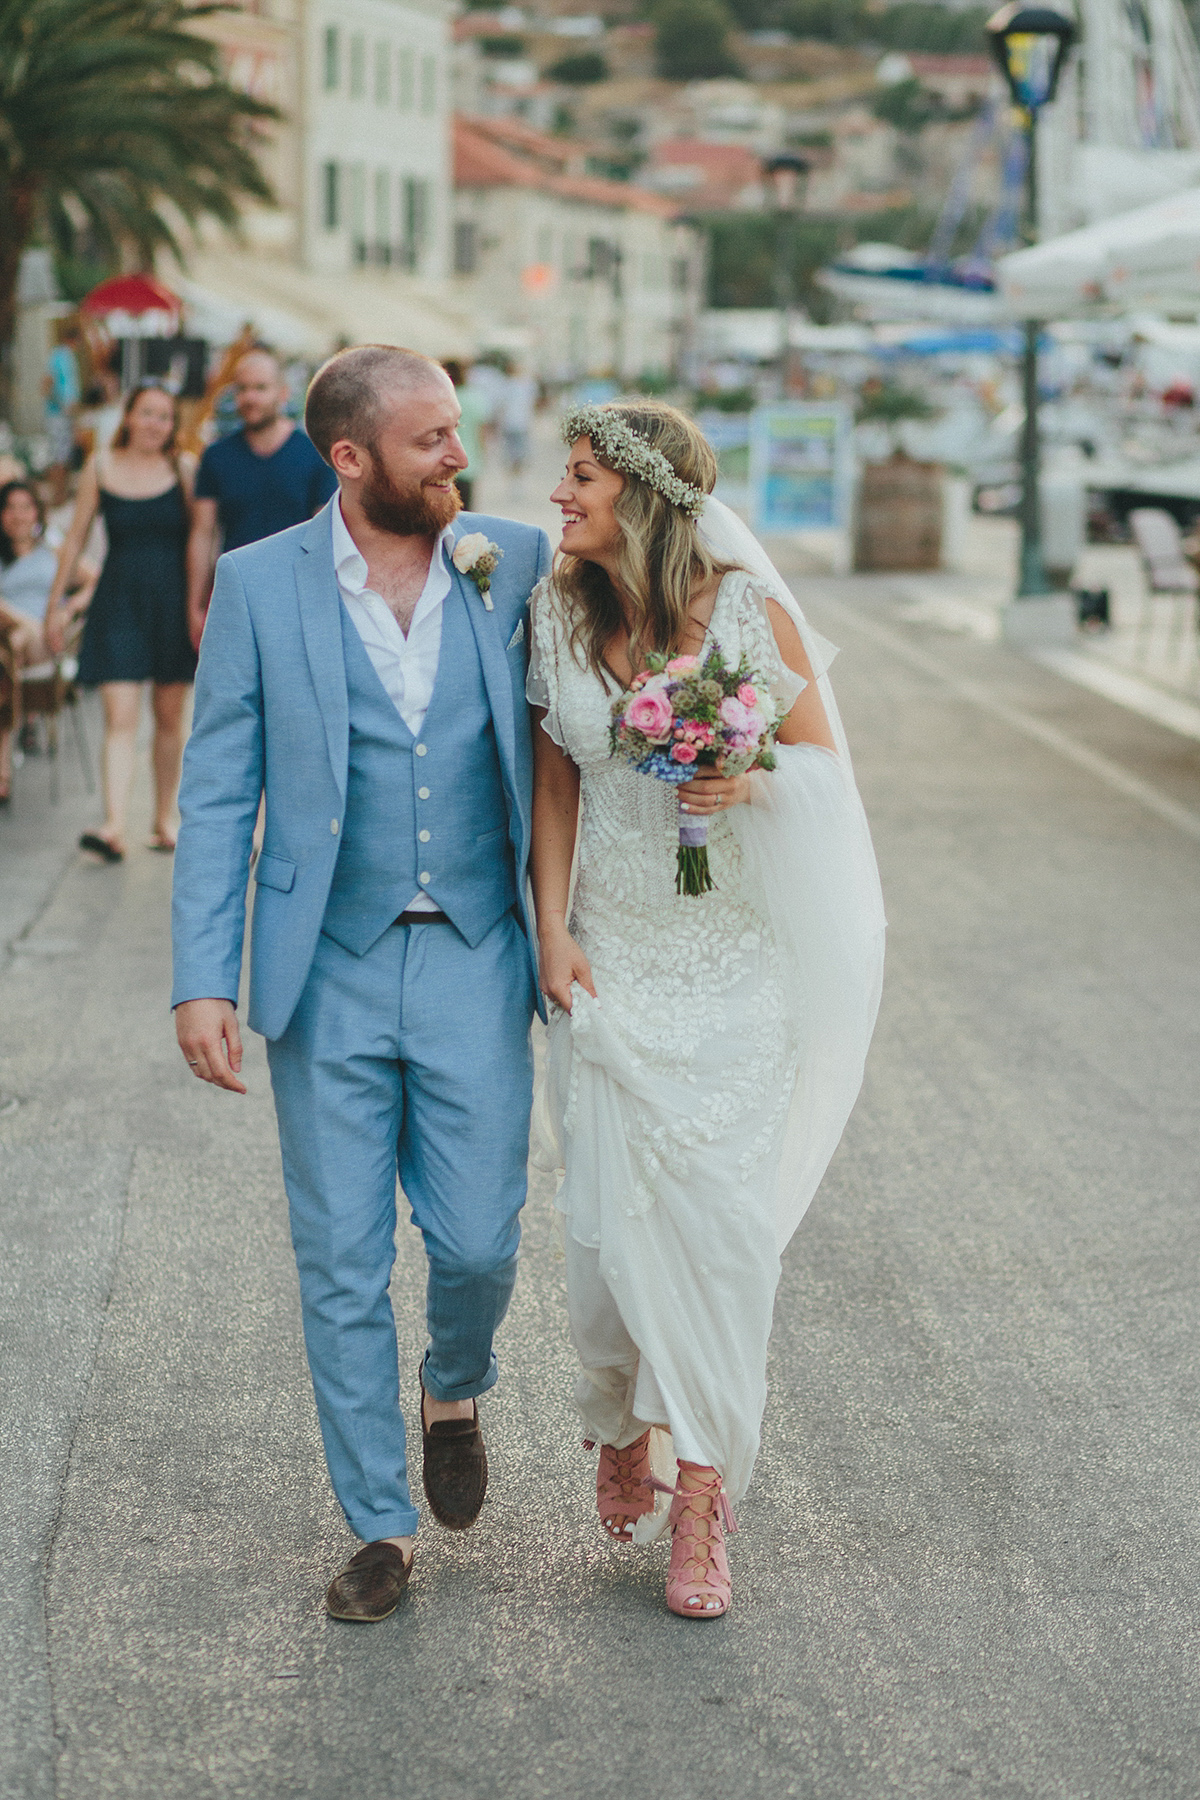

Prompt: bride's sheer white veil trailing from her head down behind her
xmin=698 ymin=497 xmax=885 ymax=1249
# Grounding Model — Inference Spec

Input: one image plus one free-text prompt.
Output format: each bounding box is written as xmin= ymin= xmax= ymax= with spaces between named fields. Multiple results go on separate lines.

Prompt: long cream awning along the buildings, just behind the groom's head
xmin=161 ymin=250 xmax=479 ymax=358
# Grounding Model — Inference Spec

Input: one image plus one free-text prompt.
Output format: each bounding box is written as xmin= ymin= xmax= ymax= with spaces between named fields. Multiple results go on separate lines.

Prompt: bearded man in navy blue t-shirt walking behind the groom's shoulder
xmin=187 ymin=344 xmax=338 ymax=646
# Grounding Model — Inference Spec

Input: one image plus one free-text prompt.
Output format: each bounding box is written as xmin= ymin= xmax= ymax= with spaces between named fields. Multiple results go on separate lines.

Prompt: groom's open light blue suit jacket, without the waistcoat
xmin=171 ymin=502 xmax=552 ymax=1039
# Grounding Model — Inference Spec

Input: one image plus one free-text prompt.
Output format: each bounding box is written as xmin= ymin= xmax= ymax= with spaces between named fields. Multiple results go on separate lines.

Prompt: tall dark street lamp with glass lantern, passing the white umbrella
xmin=988 ymin=0 xmax=1076 ymax=599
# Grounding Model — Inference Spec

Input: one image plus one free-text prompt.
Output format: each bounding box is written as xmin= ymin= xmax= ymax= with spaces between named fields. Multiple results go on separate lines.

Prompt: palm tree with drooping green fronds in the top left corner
xmin=0 ymin=0 xmax=279 ymax=405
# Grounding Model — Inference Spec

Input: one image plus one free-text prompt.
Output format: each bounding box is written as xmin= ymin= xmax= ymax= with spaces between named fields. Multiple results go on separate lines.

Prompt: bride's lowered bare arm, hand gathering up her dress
xmin=529 ymin=707 xmax=596 ymax=1012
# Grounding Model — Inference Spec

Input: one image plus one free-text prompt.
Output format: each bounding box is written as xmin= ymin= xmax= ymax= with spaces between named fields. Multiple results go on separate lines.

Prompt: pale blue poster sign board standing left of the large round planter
xmin=750 ymin=401 xmax=853 ymax=533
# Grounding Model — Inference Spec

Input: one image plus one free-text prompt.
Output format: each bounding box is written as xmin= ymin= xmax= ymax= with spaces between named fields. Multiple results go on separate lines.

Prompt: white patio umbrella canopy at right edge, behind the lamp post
xmin=997 ymin=187 xmax=1200 ymax=319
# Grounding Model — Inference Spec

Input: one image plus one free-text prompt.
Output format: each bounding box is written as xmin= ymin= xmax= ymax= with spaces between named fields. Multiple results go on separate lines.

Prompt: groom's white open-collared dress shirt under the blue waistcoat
xmin=329 ymin=499 xmax=453 ymax=913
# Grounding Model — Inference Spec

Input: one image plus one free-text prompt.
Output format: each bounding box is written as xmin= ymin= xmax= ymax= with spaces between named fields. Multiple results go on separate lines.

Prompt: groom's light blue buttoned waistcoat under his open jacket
xmin=320 ymin=587 xmax=516 ymax=956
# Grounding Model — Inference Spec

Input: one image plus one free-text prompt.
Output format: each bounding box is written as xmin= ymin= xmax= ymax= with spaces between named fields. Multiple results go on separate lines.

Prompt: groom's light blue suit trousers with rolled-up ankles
xmin=266 ymin=913 xmax=533 ymax=1543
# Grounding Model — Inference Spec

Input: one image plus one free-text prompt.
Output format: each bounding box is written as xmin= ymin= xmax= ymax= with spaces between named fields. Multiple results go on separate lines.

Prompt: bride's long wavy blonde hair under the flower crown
xmin=554 ymin=398 xmax=732 ymax=680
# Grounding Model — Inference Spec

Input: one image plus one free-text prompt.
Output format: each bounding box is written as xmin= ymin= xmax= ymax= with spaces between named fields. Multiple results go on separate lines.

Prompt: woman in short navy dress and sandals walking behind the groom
xmin=47 ymin=385 xmax=196 ymax=862
